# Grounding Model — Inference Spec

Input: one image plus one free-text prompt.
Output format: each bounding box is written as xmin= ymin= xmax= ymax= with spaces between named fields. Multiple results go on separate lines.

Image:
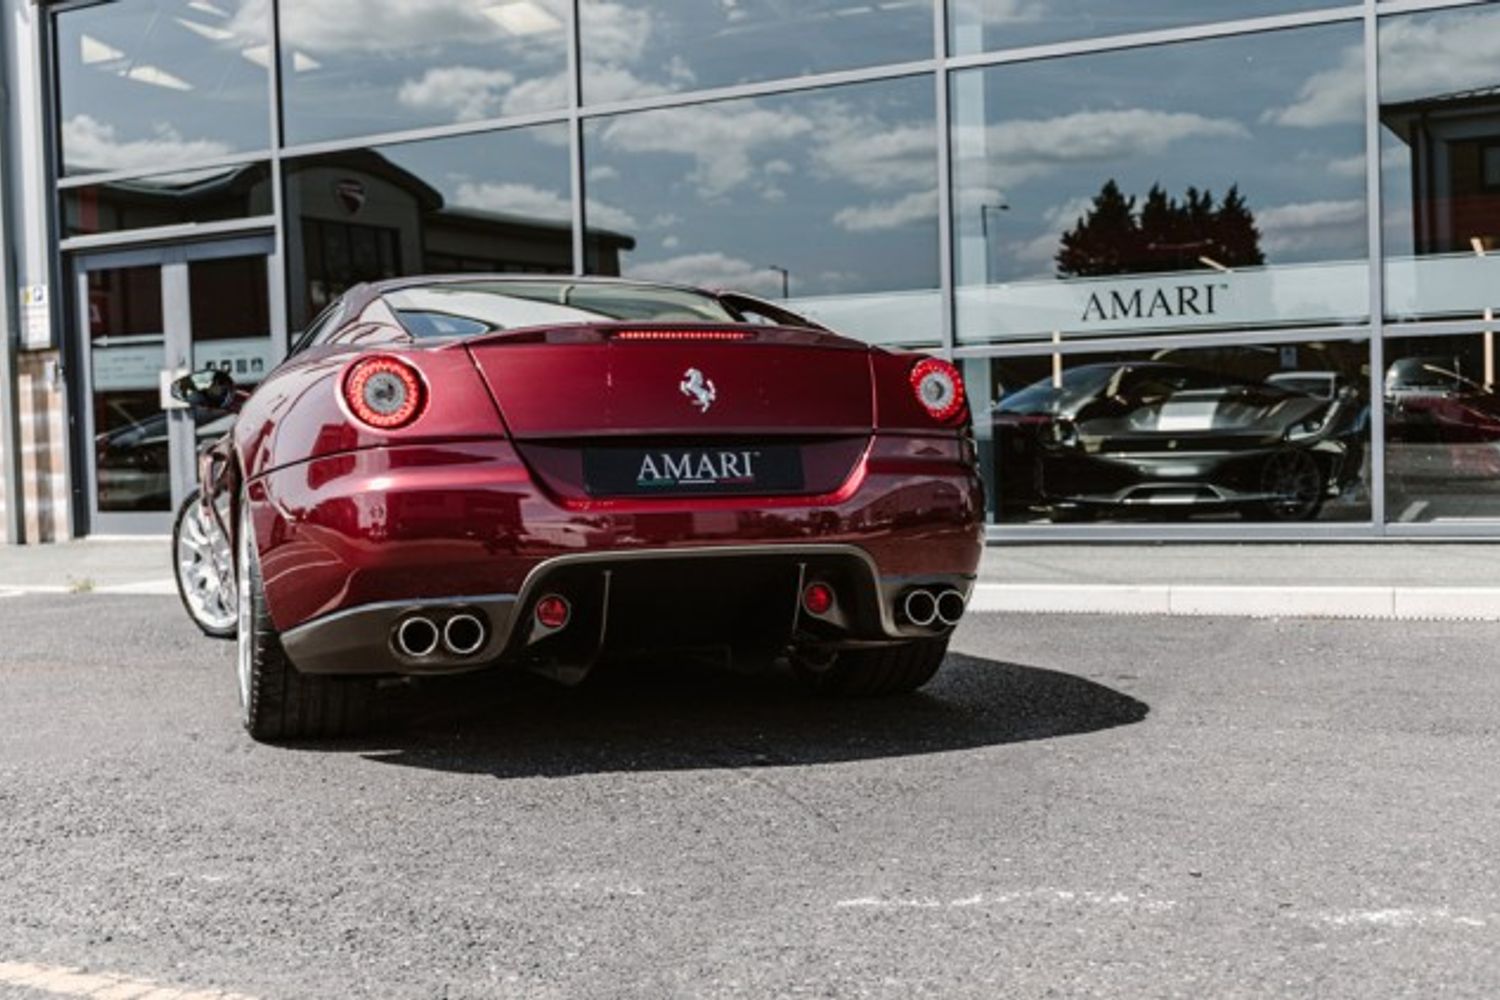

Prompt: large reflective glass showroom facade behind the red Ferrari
xmin=50 ymin=0 xmax=1500 ymax=537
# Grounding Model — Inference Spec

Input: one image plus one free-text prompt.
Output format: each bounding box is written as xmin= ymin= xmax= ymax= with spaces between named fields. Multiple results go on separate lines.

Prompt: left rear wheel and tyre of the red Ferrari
xmin=237 ymin=498 xmax=377 ymax=742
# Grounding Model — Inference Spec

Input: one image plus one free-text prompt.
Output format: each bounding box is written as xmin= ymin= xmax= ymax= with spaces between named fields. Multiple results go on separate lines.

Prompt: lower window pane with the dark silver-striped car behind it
xmin=965 ymin=340 xmax=1370 ymax=523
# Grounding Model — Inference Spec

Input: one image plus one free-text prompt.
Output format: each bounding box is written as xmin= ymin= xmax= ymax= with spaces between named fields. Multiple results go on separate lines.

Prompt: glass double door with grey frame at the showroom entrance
xmin=74 ymin=235 xmax=285 ymax=534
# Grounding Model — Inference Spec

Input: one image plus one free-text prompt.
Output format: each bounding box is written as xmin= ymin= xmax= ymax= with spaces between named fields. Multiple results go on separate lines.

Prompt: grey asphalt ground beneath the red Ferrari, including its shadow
xmin=0 ymin=594 xmax=1500 ymax=1000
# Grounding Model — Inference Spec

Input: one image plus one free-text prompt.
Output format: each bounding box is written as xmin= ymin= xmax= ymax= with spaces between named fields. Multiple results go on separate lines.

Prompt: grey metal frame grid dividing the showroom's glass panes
xmin=39 ymin=0 xmax=1500 ymax=541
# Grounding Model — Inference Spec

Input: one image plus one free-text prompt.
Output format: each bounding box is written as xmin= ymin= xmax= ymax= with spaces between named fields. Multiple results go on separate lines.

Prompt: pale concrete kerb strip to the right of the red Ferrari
xmin=969 ymin=583 xmax=1500 ymax=621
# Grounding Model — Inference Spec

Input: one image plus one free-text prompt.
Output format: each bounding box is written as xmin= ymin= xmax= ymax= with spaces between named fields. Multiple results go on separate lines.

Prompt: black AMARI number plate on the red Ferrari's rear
xmin=584 ymin=445 xmax=803 ymax=496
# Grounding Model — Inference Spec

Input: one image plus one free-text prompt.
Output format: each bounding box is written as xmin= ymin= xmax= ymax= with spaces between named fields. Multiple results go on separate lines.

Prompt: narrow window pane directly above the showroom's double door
xmin=63 ymin=163 xmax=272 ymax=237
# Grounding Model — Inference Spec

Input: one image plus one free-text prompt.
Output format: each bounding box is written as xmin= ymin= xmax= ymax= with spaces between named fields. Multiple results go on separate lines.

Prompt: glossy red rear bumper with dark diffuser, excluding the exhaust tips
xmin=248 ymin=441 xmax=983 ymax=673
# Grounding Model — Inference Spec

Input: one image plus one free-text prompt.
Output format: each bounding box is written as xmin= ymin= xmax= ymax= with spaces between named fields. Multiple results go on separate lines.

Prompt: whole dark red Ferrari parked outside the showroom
xmin=174 ymin=276 xmax=984 ymax=739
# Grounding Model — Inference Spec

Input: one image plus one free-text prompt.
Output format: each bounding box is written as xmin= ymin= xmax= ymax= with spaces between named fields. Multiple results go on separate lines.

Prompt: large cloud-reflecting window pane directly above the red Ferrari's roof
xmin=584 ymin=76 xmax=941 ymax=343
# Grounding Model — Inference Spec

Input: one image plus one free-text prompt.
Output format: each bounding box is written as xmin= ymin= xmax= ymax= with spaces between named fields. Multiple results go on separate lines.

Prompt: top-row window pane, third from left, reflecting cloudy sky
xmin=579 ymin=0 xmax=933 ymax=103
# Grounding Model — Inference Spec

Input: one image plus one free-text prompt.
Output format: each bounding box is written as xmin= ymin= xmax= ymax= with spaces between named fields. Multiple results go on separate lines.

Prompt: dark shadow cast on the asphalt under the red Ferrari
xmin=309 ymin=654 xmax=1151 ymax=778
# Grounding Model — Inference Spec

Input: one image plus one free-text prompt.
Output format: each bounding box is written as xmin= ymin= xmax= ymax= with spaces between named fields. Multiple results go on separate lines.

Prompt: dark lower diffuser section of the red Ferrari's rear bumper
xmin=282 ymin=544 xmax=974 ymax=678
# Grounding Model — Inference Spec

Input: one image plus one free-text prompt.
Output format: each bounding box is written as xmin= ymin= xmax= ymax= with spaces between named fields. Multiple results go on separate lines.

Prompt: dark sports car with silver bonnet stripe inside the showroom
xmin=990 ymin=361 xmax=1368 ymax=520
